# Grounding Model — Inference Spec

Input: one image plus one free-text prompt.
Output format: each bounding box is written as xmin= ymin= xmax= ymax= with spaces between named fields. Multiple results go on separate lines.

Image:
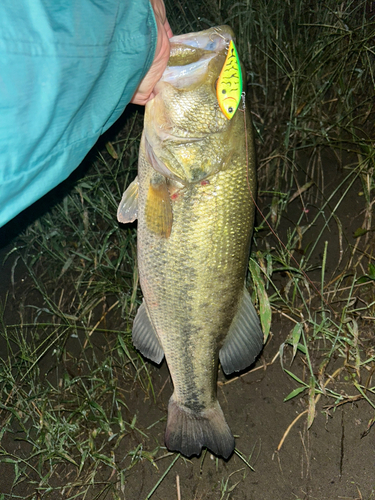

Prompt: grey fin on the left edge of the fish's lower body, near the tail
xmin=132 ymin=303 xmax=164 ymax=365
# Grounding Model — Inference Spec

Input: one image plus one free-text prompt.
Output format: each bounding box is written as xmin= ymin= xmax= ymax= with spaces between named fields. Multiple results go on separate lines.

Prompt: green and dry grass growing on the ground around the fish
xmin=0 ymin=0 xmax=375 ymax=500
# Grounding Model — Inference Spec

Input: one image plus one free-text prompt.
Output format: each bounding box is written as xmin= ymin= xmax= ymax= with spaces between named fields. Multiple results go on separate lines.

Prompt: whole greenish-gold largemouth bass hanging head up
xmin=117 ymin=26 xmax=263 ymax=459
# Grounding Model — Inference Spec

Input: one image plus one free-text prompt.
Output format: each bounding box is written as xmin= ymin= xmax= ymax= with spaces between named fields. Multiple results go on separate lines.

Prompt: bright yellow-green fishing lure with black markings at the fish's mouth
xmin=216 ymin=40 xmax=242 ymax=120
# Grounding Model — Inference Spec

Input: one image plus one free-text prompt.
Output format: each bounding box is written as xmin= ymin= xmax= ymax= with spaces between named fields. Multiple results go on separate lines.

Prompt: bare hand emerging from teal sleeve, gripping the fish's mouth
xmin=131 ymin=0 xmax=173 ymax=105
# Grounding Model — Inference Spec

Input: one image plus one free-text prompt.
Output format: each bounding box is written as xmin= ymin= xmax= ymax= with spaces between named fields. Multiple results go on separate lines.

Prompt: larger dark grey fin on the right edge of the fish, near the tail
xmin=219 ymin=288 xmax=263 ymax=375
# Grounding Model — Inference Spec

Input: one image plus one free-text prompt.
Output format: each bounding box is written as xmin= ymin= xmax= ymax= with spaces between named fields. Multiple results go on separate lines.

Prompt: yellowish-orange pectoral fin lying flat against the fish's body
xmin=145 ymin=175 xmax=173 ymax=238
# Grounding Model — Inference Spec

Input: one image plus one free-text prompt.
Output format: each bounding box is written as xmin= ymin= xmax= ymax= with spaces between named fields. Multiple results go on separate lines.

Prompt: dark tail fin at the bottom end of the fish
xmin=165 ymin=395 xmax=235 ymax=458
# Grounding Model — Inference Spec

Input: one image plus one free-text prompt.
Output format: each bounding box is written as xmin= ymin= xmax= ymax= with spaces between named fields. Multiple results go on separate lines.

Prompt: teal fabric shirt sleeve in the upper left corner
xmin=0 ymin=0 xmax=157 ymax=226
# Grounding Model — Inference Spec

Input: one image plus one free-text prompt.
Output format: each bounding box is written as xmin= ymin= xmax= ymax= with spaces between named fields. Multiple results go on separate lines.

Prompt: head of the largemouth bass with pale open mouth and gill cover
xmin=144 ymin=26 xmax=243 ymax=185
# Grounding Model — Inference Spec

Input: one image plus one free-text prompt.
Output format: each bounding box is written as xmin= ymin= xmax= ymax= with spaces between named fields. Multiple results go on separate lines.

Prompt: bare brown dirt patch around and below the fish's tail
xmin=124 ymin=336 xmax=375 ymax=500
